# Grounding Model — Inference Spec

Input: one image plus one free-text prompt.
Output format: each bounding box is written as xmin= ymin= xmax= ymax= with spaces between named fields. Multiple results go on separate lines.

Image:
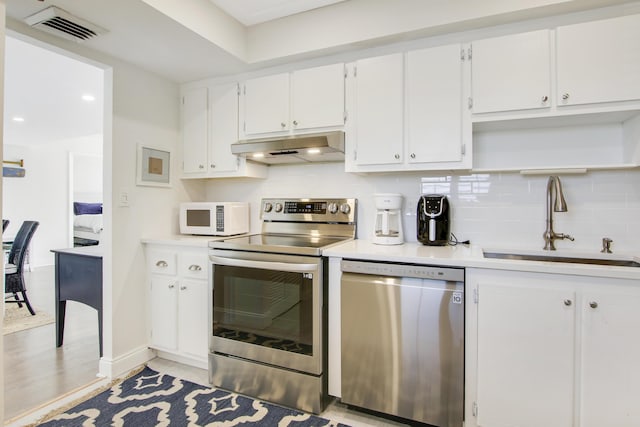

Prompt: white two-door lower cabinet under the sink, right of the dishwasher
xmin=465 ymin=269 xmax=640 ymax=427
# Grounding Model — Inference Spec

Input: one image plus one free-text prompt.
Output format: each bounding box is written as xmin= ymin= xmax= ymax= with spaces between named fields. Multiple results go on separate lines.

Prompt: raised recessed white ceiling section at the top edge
xmin=211 ymin=0 xmax=346 ymax=27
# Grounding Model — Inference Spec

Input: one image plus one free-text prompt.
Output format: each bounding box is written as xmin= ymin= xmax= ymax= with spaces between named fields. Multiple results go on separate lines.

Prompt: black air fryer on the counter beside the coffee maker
xmin=417 ymin=194 xmax=451 ymax=246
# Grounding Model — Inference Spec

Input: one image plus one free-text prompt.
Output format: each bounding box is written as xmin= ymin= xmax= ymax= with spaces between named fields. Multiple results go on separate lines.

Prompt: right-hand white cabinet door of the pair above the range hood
xmin=291 ymin=64 xmax=344 ymax=130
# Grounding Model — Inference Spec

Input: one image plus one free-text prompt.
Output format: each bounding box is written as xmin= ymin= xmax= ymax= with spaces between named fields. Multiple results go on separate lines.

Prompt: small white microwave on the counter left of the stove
xmin=179 ymin=202 xmax=249 ymax=236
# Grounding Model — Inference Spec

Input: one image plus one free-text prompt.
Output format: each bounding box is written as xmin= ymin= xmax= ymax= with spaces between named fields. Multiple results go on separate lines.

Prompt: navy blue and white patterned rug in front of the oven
xmin=38 ymin=367 xmax=348 ymax=427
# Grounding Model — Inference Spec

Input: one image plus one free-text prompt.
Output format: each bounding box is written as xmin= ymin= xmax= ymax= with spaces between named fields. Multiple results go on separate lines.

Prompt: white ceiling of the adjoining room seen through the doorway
xmin=4 ymin=37 xmax=103 ymax=145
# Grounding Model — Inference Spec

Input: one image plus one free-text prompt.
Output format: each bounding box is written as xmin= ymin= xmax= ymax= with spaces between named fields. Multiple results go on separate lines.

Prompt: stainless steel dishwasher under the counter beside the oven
xmin=341 ymin=259 xmax=464 ymax=427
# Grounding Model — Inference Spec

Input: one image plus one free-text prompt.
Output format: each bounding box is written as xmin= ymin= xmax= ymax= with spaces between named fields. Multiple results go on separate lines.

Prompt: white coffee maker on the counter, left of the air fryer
xmin=372 ymin=193 xmax=404 ymax=245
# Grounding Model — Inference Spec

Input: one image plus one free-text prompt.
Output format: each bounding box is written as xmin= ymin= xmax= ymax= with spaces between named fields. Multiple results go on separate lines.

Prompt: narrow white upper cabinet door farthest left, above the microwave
xmin=182 ymin=88 xmax=209 ymax=173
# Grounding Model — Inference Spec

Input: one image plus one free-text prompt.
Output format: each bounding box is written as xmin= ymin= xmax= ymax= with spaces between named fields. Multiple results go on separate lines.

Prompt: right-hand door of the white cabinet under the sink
xmin=580 ymin=291 xmax=640 ymax=427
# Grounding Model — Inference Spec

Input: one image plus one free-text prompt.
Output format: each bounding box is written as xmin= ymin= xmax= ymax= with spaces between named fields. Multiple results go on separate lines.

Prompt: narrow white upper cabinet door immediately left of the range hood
xmin=209 ymin=84 xmax=238 ymax=172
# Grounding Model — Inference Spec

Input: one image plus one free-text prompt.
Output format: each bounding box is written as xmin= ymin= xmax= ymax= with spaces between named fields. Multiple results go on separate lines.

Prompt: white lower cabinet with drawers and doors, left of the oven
xmin=147 ymin=245 xmax=211 ymax=366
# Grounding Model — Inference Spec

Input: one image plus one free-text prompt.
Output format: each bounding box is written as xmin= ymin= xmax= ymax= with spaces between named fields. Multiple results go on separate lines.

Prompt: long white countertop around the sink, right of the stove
xmin=323 ymin=240 xmax=640 ymax=280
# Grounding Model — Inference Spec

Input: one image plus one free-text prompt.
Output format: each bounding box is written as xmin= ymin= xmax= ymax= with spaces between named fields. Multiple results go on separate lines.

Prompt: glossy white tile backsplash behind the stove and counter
xmin=206 ymin=163 xmax=640 ymax=253
